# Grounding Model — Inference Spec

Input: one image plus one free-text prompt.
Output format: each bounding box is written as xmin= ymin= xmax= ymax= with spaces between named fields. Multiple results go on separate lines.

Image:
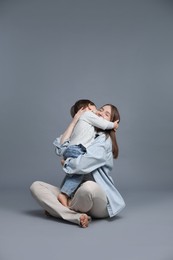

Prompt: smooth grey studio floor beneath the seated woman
xmin=0 ymin=189 xmax=173 ymax=260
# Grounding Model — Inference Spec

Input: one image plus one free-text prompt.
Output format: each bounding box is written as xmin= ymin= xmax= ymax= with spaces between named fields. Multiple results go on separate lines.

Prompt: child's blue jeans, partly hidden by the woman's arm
xmin=61 ymin=144 xmax=86 ymax=197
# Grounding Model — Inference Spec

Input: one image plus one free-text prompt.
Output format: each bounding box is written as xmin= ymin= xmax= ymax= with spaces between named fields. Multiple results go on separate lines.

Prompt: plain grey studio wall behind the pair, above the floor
xmin=0 ymin=0 xmax=173 ymax=189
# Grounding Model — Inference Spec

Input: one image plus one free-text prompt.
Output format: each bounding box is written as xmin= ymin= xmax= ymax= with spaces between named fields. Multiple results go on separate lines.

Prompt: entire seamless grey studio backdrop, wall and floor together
xmin=0 ymin=0 xmax=173 ymax=260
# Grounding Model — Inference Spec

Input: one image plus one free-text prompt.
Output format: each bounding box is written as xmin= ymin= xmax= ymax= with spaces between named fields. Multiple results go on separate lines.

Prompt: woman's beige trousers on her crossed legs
xmin=30 ymin=181 xmax=108 ymax=225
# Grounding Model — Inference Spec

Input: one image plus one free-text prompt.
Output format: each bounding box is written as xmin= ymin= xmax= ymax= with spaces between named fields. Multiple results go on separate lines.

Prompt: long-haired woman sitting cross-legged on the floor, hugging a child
xmin=30 ymin=104 xmax=125 ymax=228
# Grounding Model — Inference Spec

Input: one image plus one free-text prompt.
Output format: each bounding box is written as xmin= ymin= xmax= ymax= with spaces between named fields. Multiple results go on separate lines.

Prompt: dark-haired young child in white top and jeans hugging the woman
xmin=53 ymin=99 xmax=118 ymax=206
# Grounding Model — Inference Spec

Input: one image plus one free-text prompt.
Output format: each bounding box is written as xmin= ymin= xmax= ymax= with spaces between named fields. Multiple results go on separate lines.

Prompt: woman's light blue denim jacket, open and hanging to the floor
xmin=53 ymin=132 xmax=125 ymax=217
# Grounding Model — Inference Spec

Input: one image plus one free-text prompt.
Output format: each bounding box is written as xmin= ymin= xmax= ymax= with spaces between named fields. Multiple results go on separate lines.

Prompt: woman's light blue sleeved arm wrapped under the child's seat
xmin=63 ymin=134 xmax=113 ymax=174
